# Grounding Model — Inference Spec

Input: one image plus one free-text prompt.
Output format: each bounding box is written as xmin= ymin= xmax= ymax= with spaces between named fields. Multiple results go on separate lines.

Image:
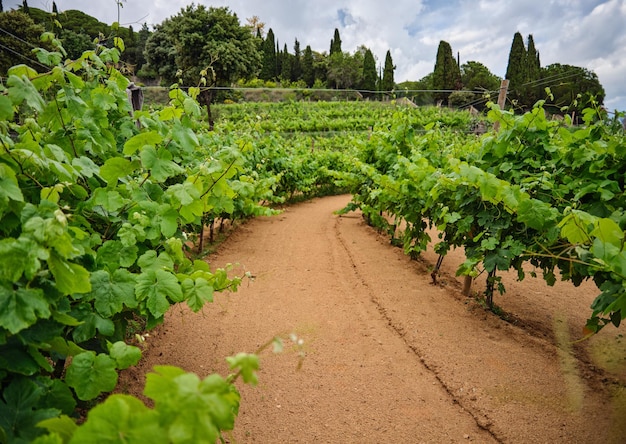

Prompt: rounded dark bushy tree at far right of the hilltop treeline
xmin=541 ymin=63 xmax=605 ymax=115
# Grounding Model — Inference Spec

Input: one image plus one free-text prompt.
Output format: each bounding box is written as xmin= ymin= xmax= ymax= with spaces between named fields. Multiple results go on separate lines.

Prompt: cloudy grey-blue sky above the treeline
xmin=3 ymin=0 xmax=626 ymax=110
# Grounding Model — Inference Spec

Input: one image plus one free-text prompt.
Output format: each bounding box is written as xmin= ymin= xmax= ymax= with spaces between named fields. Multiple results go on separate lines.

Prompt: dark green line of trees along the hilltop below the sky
xmin=0 ymin=0 xmax=605 ymax=114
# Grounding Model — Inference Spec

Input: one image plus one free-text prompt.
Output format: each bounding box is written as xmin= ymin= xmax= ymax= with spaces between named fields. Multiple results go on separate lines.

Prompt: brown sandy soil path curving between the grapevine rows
xmin=125 ymin=196 xmax=626 ymax=443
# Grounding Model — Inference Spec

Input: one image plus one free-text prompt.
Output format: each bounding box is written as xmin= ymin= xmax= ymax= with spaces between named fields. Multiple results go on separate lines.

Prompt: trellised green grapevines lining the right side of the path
xmin=347 ymin=99 xmax=626 ymax=332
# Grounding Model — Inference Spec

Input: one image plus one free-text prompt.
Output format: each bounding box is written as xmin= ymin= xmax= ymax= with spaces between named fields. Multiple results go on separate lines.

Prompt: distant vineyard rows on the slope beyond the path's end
xmin=215 ymin=101 xmax=475 ymax=200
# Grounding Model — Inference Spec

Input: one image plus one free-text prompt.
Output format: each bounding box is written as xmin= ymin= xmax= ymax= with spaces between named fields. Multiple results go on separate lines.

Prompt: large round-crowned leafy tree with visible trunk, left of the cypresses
xmin=146 ymin=4 xmax=261 ymax=125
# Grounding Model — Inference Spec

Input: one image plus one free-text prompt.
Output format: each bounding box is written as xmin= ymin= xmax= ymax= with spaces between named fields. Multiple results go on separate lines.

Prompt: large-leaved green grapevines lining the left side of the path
xmin=0 ymin=35 xmax=276 ymax=443
